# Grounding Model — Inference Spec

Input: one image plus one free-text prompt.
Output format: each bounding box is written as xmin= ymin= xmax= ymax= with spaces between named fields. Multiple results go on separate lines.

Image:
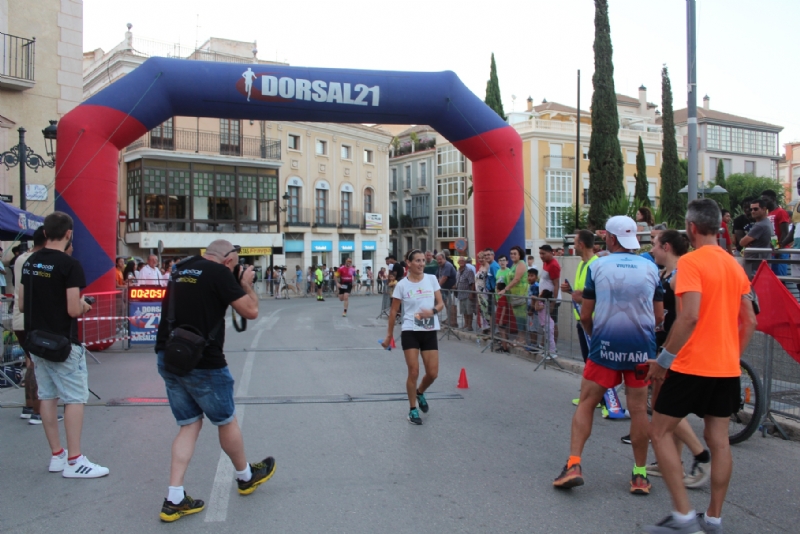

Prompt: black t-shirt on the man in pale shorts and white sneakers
xmin=22 ymin=248 xmax=86 ymax=345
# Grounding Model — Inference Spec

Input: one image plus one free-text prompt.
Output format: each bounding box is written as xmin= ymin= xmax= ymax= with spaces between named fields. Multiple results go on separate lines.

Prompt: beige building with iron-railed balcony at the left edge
xmin=0 ymin=0 xmax=83 ymax=220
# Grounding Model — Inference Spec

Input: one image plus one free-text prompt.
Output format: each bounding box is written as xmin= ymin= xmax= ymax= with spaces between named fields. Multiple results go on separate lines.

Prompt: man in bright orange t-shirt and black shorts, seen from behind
xmin=645 ymin=199 xmax=756 ymax=534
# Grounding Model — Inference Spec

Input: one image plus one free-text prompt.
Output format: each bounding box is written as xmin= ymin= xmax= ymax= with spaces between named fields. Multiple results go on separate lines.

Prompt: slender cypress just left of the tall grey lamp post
xmin=661 ymin=66 xmax=685 ymax=228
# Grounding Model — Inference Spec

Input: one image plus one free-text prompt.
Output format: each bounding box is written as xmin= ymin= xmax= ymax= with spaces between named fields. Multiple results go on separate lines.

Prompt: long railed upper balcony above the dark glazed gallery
xmin=126 ymin=128 xmax=281 ymax=160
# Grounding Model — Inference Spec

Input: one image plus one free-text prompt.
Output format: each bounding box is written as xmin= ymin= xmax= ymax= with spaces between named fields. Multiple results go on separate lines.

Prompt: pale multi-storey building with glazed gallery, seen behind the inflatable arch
xmin=84 ymin=26 xmax=391 ymax=273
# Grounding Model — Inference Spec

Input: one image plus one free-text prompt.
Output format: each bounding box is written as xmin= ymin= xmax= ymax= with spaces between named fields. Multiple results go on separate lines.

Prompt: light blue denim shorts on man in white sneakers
xmin=31 ymin=345 xmax=89 ymax=404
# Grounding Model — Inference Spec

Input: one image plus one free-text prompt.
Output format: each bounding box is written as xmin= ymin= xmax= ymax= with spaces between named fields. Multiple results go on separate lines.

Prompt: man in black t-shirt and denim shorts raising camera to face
xmin=156 ymin=239 xmax=275 ymax=522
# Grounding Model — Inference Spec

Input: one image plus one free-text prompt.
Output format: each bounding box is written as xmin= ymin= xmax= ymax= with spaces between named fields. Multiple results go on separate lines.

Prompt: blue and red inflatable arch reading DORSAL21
xmin=56 ymin=58 xmax=525 ymax=291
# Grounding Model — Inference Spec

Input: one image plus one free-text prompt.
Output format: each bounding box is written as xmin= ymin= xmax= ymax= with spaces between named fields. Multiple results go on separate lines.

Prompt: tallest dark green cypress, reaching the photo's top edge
xmin=589 ymin=0 xmax=625 ymax=228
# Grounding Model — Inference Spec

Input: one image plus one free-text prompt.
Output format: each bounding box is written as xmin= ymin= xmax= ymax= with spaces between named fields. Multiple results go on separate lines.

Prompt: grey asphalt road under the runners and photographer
xmin=0 ymin=297 xmax=800 ymax=534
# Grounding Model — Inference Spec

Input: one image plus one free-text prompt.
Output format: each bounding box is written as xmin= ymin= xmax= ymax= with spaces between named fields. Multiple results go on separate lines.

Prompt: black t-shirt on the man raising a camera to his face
xmin=156 ymin=257 xmax=246 ymax=369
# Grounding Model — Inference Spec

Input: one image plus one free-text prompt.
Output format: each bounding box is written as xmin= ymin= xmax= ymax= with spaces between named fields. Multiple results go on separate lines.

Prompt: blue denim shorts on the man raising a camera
xmin=158 ymin=351 xmax=236 ymax=426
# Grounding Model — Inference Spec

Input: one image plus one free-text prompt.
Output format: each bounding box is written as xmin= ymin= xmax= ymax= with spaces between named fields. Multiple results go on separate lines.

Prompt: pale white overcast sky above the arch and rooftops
xmin=83 ymin=0 xmax=800 ymax=152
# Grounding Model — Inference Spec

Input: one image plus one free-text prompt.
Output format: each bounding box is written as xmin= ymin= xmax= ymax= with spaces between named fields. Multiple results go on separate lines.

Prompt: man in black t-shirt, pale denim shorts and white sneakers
xmin=19 ymin=211 xmax=108 ymax=478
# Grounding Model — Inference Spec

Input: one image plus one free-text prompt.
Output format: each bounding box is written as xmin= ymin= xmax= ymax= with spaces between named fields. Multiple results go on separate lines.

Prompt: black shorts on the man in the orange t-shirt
xmin=654 ymin=371 xmax=742 ymax=419
